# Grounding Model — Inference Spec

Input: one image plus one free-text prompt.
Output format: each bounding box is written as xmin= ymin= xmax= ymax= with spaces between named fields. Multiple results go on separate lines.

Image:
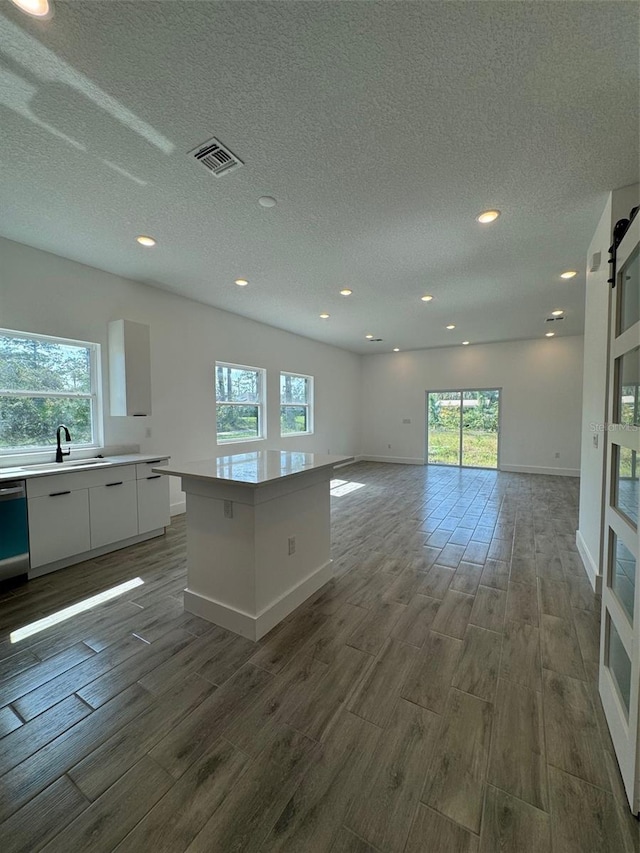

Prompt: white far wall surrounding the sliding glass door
xmin=362 ymin=336 xmax=582 ymax=476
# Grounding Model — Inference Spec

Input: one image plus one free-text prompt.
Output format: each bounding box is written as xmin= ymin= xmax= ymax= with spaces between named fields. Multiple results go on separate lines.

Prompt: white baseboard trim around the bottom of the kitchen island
xmin=184 ymin=560 xmax=333 ymax=642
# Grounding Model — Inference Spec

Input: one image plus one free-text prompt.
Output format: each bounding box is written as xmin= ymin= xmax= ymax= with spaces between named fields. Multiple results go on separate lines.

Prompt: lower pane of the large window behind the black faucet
xmin=0 ymin=397 xmax=92 ymax=448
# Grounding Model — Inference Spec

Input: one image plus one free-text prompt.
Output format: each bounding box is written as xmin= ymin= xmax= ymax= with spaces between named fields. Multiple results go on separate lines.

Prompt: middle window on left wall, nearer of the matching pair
xmin=216 ymin=362 xmax=265 ymax=443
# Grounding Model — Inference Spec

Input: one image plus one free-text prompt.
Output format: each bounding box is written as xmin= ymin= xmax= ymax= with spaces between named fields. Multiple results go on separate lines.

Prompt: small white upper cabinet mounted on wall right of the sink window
xmin=109 ymin=320 xmax=151 ymax=417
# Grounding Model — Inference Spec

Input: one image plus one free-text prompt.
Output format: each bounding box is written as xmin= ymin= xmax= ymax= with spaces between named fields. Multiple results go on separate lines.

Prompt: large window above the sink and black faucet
xmin=0 ymin=329 xmax=100 ymax=454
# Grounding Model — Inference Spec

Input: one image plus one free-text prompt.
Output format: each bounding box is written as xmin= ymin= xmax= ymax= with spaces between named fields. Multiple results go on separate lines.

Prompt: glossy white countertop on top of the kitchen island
xmin=152 ymin=450 xmax=354 ymax=488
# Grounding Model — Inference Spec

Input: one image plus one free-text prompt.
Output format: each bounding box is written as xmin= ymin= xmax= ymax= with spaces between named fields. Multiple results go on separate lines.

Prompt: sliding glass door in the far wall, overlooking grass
xmin=427 ymin=388 xmax=500 ymax=468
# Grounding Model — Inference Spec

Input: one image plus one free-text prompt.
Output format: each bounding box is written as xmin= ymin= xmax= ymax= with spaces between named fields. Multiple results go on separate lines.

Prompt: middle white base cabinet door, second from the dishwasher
xmin=89 ymin=480 xmax=138 ymax=548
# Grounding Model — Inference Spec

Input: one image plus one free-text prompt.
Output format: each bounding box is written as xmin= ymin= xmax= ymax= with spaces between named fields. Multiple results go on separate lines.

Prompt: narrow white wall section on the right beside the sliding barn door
xmin=576 ymin=184 xmax=640 ymax=592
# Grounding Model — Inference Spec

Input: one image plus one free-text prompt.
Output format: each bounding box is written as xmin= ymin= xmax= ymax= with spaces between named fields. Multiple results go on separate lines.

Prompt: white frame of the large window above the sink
xmin=0 ymin=328 xmax=103 ymax=460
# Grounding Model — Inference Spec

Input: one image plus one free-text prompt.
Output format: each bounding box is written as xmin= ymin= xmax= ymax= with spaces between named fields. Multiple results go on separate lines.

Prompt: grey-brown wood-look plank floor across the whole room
xmin=0 ymin=463 xmax=638 ymax=853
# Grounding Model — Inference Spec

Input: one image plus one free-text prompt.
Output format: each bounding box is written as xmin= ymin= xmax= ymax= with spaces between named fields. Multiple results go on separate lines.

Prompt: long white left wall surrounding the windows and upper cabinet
xmin=0 ymin=238 xmax=360 ymax=510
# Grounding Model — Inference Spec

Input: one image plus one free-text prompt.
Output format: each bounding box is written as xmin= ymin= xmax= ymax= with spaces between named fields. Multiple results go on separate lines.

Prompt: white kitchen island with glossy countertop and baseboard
xmin=154 ymin=450 xmax=353 ymax=640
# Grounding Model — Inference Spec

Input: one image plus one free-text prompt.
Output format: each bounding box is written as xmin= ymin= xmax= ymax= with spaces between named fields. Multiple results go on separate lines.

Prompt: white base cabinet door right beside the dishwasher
xmin=28 ymin=489 xmax=91 ymax=569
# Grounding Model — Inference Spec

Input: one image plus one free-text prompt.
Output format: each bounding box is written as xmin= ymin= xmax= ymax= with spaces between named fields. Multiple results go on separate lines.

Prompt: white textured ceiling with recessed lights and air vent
xmin=0 ymin=0 xmax=640 ymax=353
